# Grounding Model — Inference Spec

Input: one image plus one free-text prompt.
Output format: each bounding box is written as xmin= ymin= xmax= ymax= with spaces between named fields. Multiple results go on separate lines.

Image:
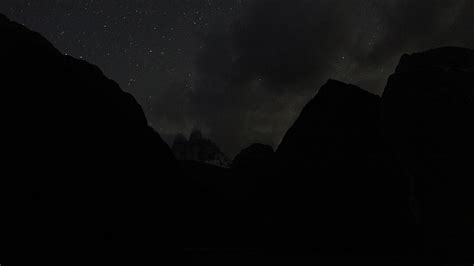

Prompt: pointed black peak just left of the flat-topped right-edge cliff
xmin=275 ymin=80 xmax=409 ymax=252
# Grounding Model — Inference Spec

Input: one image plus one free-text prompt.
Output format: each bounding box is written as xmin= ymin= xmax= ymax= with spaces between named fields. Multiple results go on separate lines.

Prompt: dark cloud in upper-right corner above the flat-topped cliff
xmin=362 ymin=0 xmax=474 ymax=64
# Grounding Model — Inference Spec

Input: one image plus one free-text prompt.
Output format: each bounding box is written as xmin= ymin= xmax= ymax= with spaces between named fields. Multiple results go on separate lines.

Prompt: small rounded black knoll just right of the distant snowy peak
xmin=232 ymin=143 xmax=275 ymax=170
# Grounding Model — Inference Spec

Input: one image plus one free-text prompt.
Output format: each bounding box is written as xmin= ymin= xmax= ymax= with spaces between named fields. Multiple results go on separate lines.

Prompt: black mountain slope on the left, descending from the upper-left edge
xmin=0 ymin=13 xmax=179 ymax=255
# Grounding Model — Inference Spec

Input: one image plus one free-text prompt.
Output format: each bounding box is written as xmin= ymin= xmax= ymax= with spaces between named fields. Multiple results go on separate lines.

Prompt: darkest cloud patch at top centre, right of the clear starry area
xmin=198 ymin=0 xmax=356 ymax=90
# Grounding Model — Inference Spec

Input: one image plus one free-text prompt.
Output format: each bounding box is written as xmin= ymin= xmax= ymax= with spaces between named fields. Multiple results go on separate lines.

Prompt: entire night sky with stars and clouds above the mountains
xmin=0 ymin=0 xmax=474 ymax=157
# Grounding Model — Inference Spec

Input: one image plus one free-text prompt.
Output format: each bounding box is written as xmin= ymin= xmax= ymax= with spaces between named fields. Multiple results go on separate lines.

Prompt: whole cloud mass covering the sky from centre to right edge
xmin=184 ymin=0 xmax=474 ymax=154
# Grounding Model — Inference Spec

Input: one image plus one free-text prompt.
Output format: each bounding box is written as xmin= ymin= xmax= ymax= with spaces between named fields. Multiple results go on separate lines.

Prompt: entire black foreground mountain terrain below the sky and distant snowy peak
xmin=0 ymin=15 xmax=474 ymax=265
